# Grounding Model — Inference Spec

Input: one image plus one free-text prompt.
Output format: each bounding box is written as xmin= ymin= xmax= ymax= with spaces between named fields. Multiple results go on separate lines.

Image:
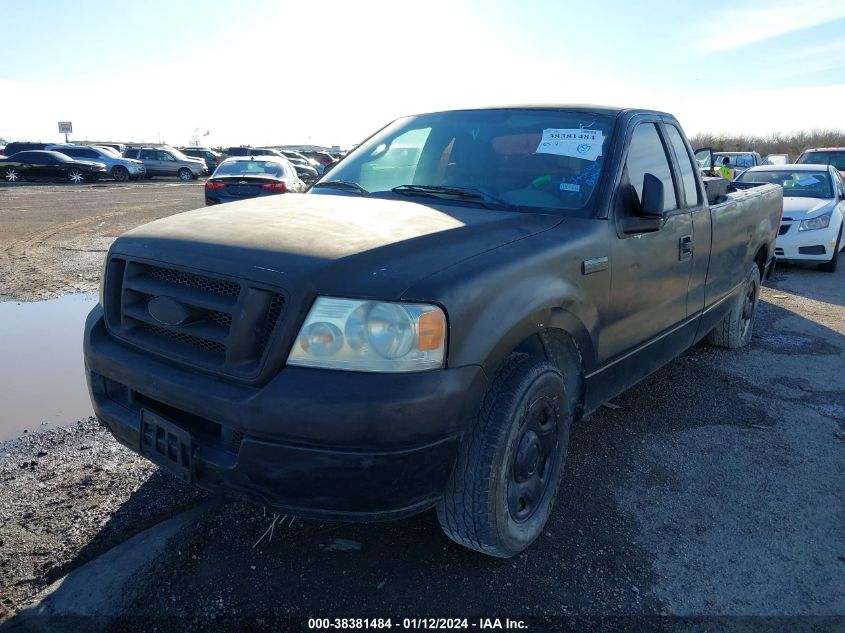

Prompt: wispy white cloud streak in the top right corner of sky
xmin=697 ymin=0 xmax=845 ymax=53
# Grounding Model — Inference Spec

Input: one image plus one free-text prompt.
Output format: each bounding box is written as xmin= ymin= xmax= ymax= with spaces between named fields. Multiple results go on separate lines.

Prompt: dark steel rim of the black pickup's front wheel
xmin=507 ymin=397 xmax=560 ymax=523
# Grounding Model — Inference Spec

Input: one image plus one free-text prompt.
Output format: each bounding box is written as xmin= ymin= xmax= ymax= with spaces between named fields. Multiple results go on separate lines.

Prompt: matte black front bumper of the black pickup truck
xmin=84 ymin=306 xmax=487 ymax=521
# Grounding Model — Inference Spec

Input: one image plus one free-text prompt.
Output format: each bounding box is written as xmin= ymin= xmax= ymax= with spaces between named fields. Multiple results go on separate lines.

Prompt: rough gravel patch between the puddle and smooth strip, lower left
xmin=0 ymin=418 xmax=203 ymax=622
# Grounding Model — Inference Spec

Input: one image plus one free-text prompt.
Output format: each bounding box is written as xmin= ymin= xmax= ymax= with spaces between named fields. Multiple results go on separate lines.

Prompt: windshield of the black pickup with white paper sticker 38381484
xmin=316 ymin=109 xmax=614 ymax=213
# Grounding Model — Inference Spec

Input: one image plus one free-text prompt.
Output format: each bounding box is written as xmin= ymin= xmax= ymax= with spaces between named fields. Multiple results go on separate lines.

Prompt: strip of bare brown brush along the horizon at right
xmin=690 ymin=129 xmax=845 ymax=160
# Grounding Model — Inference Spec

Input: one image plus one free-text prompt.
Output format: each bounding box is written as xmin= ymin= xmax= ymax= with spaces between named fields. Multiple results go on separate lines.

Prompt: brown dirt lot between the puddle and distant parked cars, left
xmin=0 ymin=180 xmax=204 ymax=300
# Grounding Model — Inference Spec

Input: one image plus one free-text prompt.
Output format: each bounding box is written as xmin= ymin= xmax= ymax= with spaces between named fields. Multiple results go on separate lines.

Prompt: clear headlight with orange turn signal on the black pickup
xmin=288 ymin=297 xmax=446 ymax=372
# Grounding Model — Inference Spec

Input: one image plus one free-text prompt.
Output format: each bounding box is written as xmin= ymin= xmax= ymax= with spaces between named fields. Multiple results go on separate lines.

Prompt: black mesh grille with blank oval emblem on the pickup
xmin=106 ymin=258 xmax=285 ymax=378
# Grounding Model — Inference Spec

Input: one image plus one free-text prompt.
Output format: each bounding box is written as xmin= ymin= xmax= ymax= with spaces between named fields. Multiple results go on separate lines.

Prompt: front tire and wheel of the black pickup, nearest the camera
xmin=437 ymin=354 xmax=571 ymax=558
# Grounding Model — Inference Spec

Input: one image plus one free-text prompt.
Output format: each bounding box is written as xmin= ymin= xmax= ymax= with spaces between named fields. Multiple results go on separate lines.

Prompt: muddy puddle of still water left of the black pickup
xmin=0 ymin=294 xmax=97 ymax=440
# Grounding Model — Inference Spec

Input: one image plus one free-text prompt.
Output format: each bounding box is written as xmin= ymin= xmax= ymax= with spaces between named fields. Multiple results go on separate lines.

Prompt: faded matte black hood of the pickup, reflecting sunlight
xmin=112 ymin=194 xmax=562 ymax=299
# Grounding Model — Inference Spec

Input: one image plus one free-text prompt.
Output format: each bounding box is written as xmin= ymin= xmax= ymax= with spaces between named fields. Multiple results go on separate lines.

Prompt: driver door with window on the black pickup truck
xmin=599 ymin=120 xmax=694 ymax=385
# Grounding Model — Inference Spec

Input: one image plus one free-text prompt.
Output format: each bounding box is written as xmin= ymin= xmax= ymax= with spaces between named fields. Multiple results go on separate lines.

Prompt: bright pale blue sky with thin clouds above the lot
xmin=0 ymin=0 xmax=845 ymax=147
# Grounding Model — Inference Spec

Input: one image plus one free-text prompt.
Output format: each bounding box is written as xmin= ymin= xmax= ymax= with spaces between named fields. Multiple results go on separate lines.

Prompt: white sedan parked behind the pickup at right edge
xmin=737 ymin=164 xmax=845 ymax=272
